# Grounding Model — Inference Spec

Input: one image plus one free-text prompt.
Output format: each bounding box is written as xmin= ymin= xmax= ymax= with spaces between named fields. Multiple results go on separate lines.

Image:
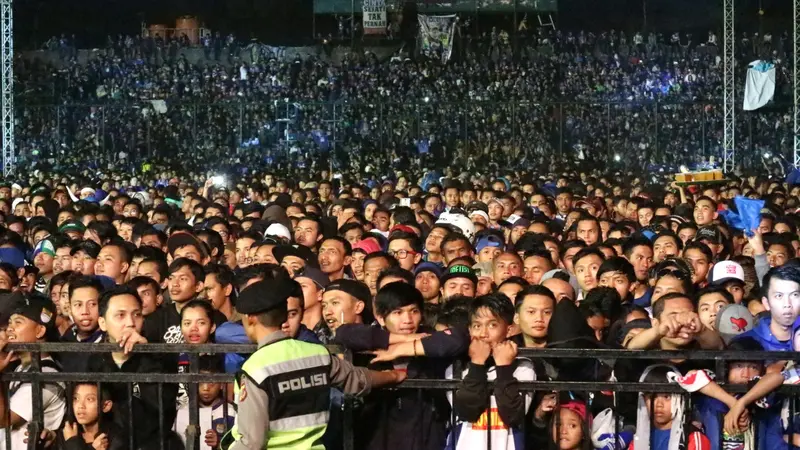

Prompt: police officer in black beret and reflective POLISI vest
xmin=223 ymin=276 xmax=405 ymax=450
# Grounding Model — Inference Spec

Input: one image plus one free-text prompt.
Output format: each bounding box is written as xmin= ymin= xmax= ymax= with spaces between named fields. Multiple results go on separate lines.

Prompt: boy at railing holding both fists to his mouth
xmin=445 ymin=294 xmax=536 ymax=450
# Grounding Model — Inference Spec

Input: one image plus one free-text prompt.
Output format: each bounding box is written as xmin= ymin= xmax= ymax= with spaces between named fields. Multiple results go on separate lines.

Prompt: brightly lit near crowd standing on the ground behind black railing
xmin=0 ymin=156 xmax=800 ymax=450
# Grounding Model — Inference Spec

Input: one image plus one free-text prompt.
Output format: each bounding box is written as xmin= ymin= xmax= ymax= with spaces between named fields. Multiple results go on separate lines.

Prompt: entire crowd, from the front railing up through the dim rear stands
xmin=0 ymin=19 xmax=800 ymax=450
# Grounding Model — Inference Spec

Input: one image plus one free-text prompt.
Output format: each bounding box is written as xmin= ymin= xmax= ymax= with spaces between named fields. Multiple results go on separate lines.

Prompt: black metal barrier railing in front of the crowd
xmin=0 ymin=343 xmax=800 ymax=450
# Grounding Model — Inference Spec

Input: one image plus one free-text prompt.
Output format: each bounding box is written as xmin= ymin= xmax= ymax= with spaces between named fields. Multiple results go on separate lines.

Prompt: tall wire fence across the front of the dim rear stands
xmin=16 ymin=98 xmax=793 ymax=167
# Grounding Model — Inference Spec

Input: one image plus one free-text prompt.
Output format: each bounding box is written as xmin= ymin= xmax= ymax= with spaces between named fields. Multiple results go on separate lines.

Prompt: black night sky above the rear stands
xmin=15 ymin=0 xmax=791 ymax=47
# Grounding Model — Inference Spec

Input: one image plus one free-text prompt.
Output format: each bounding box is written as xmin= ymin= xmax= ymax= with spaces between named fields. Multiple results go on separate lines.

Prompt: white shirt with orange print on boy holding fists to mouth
xmin=445 ymin=358 xmax=536 ymax=450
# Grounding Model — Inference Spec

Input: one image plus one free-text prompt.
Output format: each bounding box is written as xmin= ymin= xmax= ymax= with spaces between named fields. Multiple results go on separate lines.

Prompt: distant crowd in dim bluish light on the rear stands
xmin=12 ymin=25 xmax=792 ymax=175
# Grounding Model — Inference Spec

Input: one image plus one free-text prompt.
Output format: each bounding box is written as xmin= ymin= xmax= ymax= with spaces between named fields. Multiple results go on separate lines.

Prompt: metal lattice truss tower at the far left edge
xmin=0 ymin=0 xmax=11 ymax=177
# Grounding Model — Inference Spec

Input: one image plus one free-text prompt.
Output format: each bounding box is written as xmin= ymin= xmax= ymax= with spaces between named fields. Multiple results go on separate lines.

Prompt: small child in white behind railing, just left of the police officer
xmin=174 ymin=355 xmax=236 ymax=450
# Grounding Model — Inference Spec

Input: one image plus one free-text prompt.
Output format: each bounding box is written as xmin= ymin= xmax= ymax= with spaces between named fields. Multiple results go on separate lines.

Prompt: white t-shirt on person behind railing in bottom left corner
xmin=0 ymin=358 xmax=67 ymax=450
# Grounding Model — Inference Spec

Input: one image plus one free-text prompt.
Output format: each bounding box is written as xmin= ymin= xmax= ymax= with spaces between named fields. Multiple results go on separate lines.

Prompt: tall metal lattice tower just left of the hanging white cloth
xmin=723 ymin=0 xmax=736 ymax=173
